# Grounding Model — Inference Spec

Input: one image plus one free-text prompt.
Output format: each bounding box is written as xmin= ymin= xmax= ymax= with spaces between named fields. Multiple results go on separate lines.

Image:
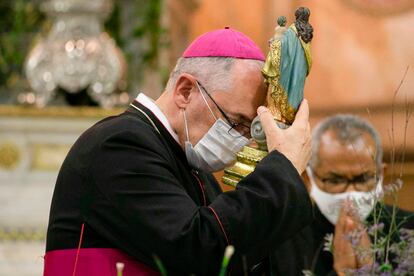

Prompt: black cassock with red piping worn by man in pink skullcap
xmin=46 ymin=102 xmax=312 ymax=275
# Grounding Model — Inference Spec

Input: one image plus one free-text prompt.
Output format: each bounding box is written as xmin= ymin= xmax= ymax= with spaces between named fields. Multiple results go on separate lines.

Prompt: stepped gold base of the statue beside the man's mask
xmin=222 ymin=146 xmax=268 ymax=187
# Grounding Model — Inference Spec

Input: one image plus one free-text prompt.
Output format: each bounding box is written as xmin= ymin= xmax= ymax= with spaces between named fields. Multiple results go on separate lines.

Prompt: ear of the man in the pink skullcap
xmin=173 ymin=73 xmax=196 ymax=109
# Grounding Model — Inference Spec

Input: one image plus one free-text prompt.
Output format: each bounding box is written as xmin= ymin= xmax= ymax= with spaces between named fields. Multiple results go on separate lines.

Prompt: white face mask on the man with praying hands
xmin=306 ymin=167 xmax=382 ymax=225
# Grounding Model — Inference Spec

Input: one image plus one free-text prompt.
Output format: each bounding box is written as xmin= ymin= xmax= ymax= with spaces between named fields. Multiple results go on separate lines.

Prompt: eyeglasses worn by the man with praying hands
xmin=313 ymin=169 xmax=378 ymax=193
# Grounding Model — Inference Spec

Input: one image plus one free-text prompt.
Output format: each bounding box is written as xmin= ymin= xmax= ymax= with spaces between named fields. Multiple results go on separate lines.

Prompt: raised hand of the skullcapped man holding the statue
xmin=257 ymin=99 xmax=311 ymax=174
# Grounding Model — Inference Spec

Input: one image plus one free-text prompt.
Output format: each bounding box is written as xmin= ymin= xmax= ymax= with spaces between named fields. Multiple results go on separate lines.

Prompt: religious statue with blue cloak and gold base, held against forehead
xmin=223 ymin=7 xmax=313 ymax=186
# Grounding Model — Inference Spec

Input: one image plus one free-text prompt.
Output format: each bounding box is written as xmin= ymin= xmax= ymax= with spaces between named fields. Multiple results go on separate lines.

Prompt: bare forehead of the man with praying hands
xmin=317 ymin=130 xmax=376 ymax=174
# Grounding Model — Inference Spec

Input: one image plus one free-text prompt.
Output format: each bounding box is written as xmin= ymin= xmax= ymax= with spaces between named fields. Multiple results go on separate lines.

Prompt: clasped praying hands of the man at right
xmin=333 ymin=204 xmax=372 ymax=276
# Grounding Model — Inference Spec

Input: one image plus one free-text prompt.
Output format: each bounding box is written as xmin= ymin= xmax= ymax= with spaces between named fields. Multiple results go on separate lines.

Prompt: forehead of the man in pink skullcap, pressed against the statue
xmin=213 ymin=60 xmax=267 ymax=119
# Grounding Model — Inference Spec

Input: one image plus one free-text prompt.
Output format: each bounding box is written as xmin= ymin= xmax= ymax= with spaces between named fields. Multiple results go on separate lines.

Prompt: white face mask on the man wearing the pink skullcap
xmin=183 ymin=83 xmax=249 ymax=172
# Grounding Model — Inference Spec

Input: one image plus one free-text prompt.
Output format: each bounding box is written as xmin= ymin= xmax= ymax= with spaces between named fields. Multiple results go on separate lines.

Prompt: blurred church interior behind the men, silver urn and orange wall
xmin=0 ymin=0 xmax=414 ymax=276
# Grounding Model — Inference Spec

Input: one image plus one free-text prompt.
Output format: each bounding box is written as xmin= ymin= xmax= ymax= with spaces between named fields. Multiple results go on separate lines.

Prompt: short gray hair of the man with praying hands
xmin=309 ymin=114 xmax=383 ymax=170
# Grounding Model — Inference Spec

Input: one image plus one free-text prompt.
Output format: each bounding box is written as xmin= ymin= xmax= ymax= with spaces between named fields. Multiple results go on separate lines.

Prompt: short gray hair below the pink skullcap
xmin=166 ymin=57 xmax=263 ymax=91
